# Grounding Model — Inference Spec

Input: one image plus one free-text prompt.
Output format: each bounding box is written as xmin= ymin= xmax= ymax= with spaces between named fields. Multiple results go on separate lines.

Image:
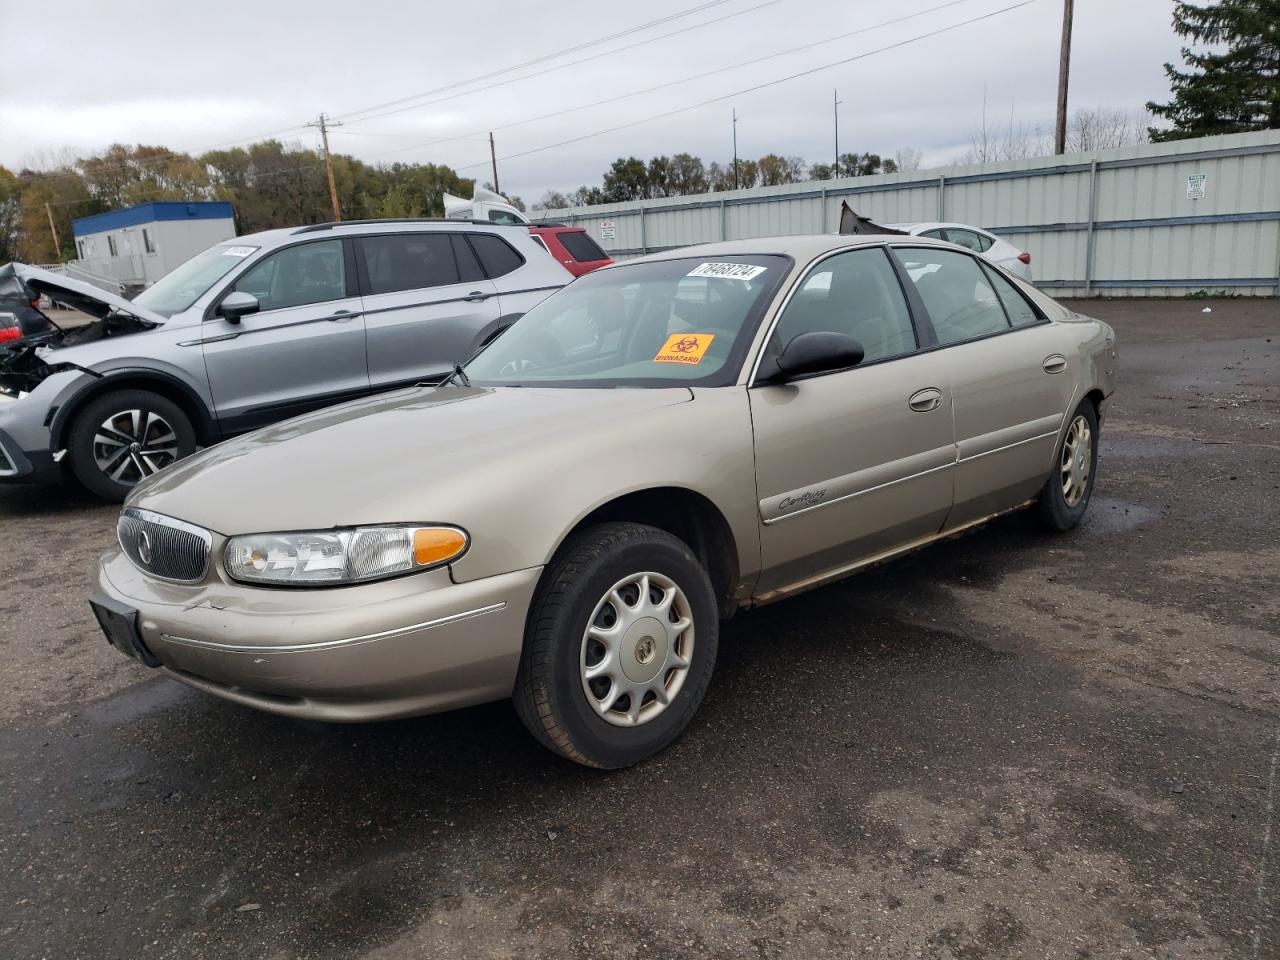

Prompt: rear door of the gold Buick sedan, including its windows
xmin=893 ymin=246 xmax=1073 ymax=527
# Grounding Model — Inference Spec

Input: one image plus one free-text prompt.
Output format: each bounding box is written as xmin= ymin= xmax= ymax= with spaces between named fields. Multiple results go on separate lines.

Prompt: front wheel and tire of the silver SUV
xmin=67 ymin=390 xmax=196 ymax=502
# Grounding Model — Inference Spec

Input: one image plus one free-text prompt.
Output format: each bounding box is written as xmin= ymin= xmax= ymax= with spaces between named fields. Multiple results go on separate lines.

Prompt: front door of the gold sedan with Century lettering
xmin=749 ymin=247 xmax=955 ymax=594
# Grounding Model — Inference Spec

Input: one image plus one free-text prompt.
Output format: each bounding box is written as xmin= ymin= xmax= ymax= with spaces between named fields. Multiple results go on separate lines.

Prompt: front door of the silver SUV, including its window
xmin=201 ymin=238 xmax=369 ymax=433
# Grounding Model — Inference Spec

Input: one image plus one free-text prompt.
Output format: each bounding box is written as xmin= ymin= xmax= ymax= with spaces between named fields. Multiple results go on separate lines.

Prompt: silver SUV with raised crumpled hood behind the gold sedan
xmin=0 ymin=220 xmax=572 ymax=500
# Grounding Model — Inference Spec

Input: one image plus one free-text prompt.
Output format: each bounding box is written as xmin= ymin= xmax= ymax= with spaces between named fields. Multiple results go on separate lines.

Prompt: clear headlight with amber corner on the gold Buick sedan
xmin=223 ymin=526 xmax=468 ymax=586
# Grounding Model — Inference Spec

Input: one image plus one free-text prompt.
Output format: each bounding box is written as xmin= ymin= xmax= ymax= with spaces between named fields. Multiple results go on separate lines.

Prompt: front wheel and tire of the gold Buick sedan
xmin=513 ymin=524 xmax=719 ymax=769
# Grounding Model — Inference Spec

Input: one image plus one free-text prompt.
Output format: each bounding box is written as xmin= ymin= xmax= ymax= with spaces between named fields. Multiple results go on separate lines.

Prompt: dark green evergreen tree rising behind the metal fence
xmin=1147 ymin=0 xmax=1280 ymax=141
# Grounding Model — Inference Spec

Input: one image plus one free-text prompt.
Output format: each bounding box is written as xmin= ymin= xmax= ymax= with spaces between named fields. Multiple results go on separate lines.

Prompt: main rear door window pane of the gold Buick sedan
xmin=895 ymin=247 xmax=1010 ymax=346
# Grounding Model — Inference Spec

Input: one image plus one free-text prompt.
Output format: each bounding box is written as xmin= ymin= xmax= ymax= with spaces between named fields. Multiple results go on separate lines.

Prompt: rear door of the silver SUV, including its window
xmin=355 ymin=232 xmax=498 ymax=390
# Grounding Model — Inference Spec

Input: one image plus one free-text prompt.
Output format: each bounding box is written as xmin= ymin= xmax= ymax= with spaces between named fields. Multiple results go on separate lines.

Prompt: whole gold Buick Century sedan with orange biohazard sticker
xmin=92 ymin=236 xmax=1116 ymax=768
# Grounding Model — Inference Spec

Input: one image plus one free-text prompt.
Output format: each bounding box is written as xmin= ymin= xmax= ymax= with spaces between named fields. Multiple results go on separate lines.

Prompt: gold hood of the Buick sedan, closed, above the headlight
xmin=128 ymin=387 xmax=692 ymax=535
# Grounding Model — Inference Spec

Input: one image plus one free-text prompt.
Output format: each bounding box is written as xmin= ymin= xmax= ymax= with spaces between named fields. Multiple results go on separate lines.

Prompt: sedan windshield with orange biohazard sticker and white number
xmin=466 ymin=256 xmax=791 ymax=387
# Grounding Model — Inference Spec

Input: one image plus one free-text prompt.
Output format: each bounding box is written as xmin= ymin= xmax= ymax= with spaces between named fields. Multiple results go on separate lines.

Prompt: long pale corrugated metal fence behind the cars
xmin=535 ymin=131 xmax=1280 ymax=296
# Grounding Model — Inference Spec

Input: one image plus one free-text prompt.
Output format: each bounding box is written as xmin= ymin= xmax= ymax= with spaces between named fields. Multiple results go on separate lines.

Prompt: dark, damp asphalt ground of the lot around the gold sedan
xmin=0 ymin=300 xmax=1280 ymax=960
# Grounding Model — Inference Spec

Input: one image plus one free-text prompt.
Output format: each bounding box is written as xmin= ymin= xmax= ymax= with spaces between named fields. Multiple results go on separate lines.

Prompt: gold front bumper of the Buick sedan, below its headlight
xmin=97 ymin=547 xmax=541 ymax=722
